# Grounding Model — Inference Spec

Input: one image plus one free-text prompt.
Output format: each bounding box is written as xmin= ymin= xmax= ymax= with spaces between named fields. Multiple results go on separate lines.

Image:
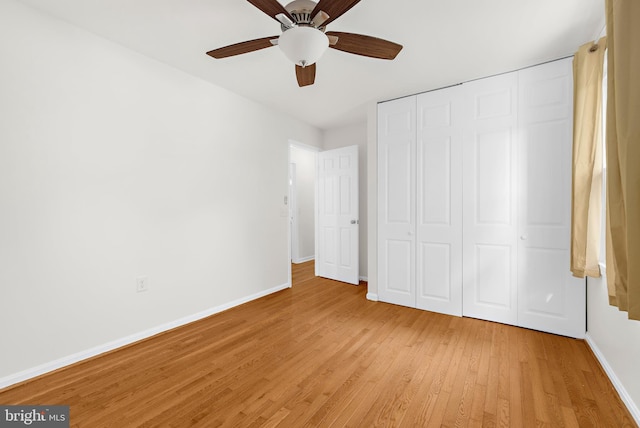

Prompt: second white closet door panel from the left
xmin=416 ymin=86 xmax=463 ymax=316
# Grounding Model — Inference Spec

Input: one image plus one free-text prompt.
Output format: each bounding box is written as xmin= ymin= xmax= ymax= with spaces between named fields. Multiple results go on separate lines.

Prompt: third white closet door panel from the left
xmin=463 ymin=73 xmax=518 ymax=325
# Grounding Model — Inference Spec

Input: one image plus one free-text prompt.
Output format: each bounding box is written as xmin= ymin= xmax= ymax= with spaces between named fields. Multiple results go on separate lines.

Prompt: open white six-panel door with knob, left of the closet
xmin=315 ymin=146 xmax=360 ymax=285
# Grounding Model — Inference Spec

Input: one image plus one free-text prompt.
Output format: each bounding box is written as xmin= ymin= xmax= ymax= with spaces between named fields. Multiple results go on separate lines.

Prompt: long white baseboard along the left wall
xmin=0 ymin=283 xmax=290 ymax=389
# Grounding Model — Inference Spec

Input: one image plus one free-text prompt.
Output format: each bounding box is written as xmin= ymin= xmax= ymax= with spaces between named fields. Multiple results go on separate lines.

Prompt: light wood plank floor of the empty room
xmin=0 ymin=262 xmax=636 ymax=428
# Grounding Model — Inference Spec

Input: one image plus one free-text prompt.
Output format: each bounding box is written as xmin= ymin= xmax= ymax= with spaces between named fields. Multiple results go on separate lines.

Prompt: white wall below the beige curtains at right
xmin=587 ymin=270 xmax=640 ymax=424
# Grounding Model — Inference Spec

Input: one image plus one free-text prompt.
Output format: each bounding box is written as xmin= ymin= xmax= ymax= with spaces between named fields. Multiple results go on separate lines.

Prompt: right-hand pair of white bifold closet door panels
xmin=463 ymin=59 xmax=586 ymax=338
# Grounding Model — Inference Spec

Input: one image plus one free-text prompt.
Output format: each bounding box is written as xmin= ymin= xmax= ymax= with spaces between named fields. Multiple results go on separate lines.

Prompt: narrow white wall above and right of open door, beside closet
xmin=322 ymin=123 xmax=369 ymax=279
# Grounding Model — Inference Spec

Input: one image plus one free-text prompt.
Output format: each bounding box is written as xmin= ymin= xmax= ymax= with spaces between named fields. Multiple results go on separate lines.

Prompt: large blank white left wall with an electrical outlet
xmin=0 ymin=0 xmax=321 ymax=385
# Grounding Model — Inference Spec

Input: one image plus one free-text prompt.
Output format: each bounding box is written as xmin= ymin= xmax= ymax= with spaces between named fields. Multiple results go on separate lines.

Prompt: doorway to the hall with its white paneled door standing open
xmin=288 ymin=141 xmax=360 ymax=285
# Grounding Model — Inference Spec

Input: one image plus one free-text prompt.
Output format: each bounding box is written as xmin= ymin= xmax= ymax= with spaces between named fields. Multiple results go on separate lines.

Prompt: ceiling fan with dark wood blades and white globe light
xmin=207 ymin=0 xmax=402 ymax=87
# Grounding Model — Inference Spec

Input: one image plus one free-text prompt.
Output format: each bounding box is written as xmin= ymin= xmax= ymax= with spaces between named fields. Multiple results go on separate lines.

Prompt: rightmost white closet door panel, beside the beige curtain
xmin=518 ymin=59 xmax=586 ymax=338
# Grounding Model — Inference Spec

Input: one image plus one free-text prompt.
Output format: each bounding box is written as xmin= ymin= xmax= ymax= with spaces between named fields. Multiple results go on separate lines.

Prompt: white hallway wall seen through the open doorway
xmin=289 ymin=146 xmax=318 ymax=263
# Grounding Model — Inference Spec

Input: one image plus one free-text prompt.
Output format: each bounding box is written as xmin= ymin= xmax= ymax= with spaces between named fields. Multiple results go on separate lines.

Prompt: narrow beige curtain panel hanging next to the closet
xmin=571 ymin=38 xmax=606 ymax=278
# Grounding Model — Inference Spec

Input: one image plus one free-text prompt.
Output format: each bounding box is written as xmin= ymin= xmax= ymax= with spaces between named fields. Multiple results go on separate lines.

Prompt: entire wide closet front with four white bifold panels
xmin=377 ymin=58 xmax=586 ymax=337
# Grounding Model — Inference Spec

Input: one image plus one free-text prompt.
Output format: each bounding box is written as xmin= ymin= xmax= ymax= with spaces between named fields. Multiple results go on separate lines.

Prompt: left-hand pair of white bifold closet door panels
xmin=378 ymin=86 xmax=462 ymax=316
